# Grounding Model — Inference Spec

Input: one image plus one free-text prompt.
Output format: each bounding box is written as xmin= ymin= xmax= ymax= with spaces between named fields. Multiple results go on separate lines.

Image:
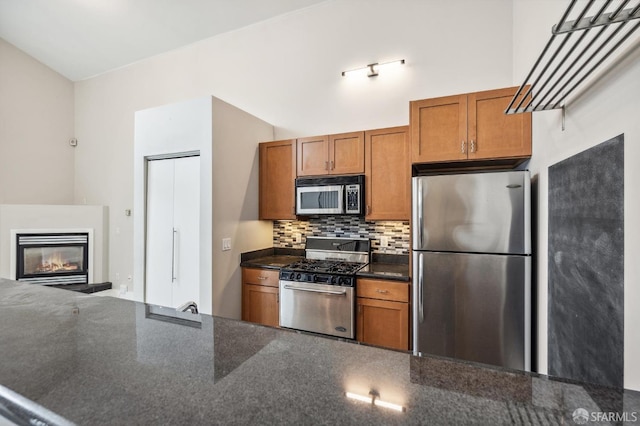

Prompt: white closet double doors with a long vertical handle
xmin=145 ymin=156 xmax=200 ymax=308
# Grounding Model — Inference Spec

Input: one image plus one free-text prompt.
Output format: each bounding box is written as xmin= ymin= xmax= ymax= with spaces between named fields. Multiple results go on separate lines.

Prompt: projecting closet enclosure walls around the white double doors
xmin=133 ymin=96 xmax=273 ymax=319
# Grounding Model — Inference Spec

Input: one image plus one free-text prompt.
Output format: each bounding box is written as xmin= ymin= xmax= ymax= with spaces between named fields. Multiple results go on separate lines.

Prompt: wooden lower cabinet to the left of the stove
xmin=242 ymin=268 xmax=280 ymax=327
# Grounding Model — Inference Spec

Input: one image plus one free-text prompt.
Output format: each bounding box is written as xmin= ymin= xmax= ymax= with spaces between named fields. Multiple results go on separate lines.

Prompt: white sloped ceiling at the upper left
xmin=0 ymin=0 xmax=325 ymax=81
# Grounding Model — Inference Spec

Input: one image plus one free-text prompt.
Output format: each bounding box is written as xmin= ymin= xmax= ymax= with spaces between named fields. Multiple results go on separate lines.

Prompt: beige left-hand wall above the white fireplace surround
xmin=0 ymin=39 xmax=74 ymax=204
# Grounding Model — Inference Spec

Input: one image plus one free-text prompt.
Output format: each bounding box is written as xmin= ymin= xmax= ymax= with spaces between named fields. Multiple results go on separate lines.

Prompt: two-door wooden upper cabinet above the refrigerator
xmin=410 ymin=87 xmax=531 ymax=163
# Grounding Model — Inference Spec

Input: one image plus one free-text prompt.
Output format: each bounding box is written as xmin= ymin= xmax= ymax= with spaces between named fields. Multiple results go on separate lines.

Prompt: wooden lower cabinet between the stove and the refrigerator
xmin=356 ymin=279 xmax=409 ymax=351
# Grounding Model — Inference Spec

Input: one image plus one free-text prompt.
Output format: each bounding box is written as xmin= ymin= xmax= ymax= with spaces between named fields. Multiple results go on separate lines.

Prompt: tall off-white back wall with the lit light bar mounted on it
xmin=74 ymin=0 xmax=512 ymax=317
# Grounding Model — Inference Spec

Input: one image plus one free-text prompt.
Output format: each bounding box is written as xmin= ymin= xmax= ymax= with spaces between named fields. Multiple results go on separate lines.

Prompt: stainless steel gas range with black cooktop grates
xmin=280 ymin=237 xmax=371 ymax=339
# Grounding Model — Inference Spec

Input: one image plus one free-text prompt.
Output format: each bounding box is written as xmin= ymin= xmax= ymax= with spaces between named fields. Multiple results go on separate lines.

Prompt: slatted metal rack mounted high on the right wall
xmin=505 ymin=0 xmax=640 ymax=114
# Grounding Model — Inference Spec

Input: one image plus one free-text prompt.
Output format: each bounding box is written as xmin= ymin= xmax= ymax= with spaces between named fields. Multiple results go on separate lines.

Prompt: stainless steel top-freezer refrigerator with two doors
xmin=412 ymin=171 xmax=531 ymax=371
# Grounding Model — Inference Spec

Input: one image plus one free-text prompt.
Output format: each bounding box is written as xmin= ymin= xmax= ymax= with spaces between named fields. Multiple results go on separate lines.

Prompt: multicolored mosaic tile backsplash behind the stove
xmin=273 ymin=216 xmax=409 ymax=255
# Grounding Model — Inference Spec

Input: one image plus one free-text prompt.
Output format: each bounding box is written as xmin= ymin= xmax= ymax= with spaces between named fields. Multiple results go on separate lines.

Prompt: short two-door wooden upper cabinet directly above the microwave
xmin=297 ymin=132 xmax=364 ymax=176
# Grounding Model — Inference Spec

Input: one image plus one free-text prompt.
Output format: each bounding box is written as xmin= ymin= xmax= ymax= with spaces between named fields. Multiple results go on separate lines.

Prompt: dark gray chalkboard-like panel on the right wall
xmin=548 ymin=135 xmax=624 ymax=387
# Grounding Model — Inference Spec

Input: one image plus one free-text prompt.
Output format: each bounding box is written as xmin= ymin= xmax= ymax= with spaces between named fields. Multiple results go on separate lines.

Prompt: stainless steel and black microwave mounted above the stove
xmin=296 ymin=175 xmax=364 ymax=216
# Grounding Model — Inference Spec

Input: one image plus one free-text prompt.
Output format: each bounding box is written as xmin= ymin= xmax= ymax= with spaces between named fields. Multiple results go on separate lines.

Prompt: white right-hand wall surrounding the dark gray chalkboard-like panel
xmin=513 ymin=0 xmax=640 ymax=390
